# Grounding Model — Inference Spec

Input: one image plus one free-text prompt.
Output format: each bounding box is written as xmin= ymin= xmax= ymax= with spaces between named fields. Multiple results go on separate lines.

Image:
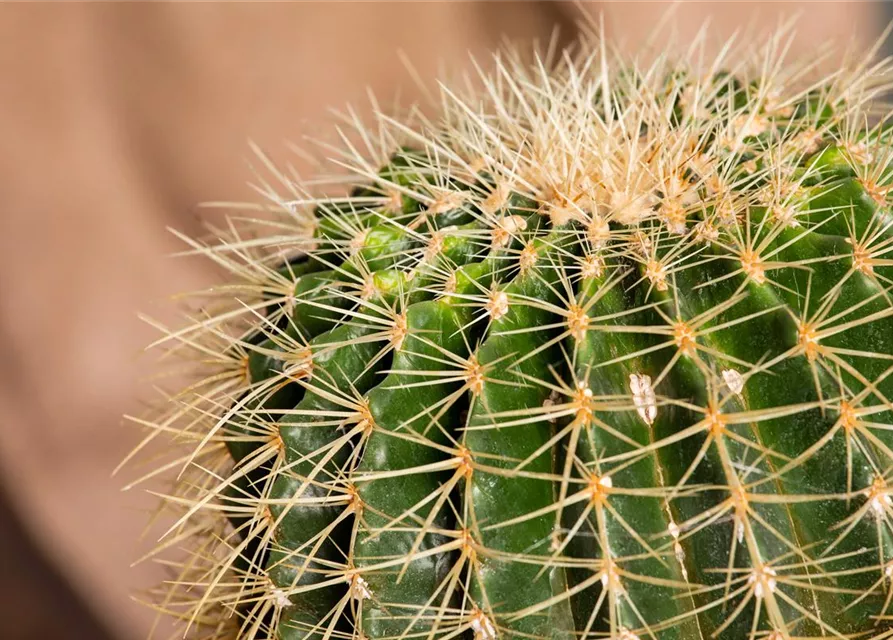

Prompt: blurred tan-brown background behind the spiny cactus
xmin=0 ymin=0 xmax=891 ymax=640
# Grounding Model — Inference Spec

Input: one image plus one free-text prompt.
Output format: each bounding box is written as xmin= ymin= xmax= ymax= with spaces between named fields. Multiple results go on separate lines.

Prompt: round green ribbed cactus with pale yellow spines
xmin=122 ymin=13 xmax=893 ymax=640
